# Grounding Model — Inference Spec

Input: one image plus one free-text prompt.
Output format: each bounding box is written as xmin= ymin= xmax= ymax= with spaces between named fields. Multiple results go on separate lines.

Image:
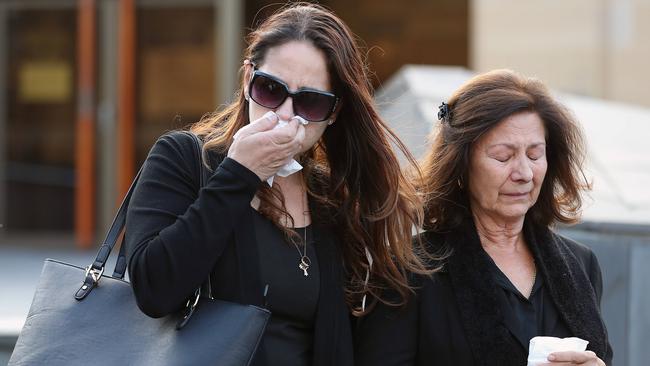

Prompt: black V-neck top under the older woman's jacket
xmin=490 ymin=254 xmax=571 ymax=352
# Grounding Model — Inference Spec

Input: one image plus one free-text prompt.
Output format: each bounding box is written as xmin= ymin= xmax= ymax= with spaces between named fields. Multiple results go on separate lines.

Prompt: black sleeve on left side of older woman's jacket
xmin=354 ymin=290 xmax=419 ymax=366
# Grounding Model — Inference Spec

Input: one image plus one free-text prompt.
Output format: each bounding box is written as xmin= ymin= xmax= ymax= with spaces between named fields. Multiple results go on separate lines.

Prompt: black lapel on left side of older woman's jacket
xmin=445 ymin=219 xmax=527 ymax=366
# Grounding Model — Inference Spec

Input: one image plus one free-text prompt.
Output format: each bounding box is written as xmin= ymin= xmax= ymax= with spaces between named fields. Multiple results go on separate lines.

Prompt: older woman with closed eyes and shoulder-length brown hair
xmin=357 ymin=70 xmax=612 ymax=366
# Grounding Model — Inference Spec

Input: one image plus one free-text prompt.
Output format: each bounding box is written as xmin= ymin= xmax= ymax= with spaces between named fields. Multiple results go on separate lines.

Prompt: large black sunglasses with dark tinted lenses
xmin=248 ymin=70 xmax=339 ymax=122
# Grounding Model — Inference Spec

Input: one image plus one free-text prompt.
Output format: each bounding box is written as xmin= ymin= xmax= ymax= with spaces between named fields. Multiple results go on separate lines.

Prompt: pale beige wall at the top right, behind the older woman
xmin=470 ymin=0 xmax=650 ymax=106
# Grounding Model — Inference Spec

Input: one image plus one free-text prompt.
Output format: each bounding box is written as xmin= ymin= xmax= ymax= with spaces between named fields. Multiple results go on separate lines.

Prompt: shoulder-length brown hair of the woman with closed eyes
xmin=417 ymin=70 xmax=590 ymax=231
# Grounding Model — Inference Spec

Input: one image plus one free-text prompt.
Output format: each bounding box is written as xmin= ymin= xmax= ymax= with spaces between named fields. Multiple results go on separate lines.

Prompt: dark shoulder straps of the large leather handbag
xmin=74 ymin=131 xmax=209 ymax=300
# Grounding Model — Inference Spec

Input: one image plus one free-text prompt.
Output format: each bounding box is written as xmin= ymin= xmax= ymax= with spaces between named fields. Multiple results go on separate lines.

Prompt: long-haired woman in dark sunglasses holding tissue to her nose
xmin=126 ymin=4 xmax=424 ymax=365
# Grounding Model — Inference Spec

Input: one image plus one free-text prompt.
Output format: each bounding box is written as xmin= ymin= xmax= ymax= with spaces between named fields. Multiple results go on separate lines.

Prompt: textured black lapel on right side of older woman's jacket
xmin=524 ymin=223 xmax=607 ymax=359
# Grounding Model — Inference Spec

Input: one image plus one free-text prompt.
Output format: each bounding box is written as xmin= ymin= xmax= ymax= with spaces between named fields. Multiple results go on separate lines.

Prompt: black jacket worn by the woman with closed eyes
xmin=355 ymin=220 xmax=612 ymax=366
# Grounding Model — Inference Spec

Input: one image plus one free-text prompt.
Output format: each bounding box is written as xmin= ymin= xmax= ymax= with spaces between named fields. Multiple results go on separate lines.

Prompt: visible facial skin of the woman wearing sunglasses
xmin=247 ymin=41 xmax=334 ymax=153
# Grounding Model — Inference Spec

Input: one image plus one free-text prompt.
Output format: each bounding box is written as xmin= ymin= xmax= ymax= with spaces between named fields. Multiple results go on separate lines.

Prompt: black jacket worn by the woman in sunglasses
xmin=126 ymin=132 xmax=353 ymax=365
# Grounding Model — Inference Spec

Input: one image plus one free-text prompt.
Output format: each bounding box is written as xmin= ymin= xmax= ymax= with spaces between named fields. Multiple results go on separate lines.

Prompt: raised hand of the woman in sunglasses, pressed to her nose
xmin=228 ymin=112 xmax=305 ymax=181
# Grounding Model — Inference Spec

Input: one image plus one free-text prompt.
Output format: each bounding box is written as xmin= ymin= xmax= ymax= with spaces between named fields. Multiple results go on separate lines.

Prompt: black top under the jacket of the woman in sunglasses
xmin=251 ymin=209 xmax=319 ymax=366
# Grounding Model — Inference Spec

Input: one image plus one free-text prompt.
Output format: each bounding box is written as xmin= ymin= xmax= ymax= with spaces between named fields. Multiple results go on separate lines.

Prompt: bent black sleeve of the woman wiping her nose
xmin=126 ymin=132 xmax=260 ymax=317
